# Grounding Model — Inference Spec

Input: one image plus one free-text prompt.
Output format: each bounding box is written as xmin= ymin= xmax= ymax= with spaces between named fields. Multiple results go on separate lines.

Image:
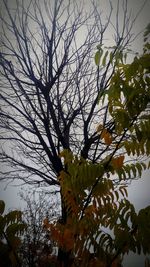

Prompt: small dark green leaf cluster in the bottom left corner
xmin=0 ymin=200 xmax=27 ymax=267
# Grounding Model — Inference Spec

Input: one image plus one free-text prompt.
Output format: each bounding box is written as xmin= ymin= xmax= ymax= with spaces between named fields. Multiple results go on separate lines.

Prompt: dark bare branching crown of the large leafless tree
xmin=0 ymin=0 xmax=143 ymax=186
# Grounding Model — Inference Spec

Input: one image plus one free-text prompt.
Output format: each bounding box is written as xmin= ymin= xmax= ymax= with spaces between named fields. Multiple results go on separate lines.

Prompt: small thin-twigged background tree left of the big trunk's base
xmin=20 ymin=189 xmax=60 ymax=267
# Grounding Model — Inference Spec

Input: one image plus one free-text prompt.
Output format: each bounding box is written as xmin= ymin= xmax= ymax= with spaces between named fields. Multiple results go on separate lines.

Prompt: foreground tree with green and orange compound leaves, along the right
xmin=44 ymin=25 xmax=150 ymax=267
